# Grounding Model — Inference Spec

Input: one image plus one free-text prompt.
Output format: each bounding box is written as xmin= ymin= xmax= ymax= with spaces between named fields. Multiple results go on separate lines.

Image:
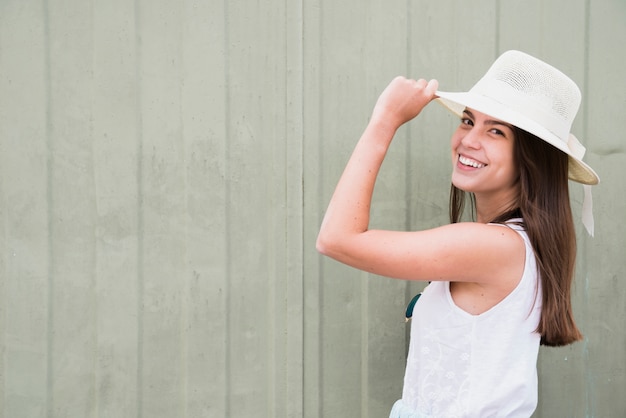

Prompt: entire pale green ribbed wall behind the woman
xmin=0 ymin=0 xmax=626 ymax=418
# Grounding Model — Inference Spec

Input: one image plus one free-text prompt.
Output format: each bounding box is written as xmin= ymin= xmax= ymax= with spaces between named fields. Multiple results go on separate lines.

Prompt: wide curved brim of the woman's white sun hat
xmin=435 ymin=91 xmax=600 ymax=185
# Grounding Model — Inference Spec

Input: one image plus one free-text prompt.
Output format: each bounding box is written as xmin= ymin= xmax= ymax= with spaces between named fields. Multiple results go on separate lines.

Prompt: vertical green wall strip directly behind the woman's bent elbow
xmin=311 ymin=1 xmax=376 ymax=416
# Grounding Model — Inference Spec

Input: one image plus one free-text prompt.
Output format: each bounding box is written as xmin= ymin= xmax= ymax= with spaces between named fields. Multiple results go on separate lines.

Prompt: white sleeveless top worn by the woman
xmin=390 ymin=224 xmax=541 ymax=418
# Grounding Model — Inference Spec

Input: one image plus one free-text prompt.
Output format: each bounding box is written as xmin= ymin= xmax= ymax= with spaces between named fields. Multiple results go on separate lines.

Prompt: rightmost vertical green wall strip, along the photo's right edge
xmin=579 ymin=1 xmax=626 ymax=417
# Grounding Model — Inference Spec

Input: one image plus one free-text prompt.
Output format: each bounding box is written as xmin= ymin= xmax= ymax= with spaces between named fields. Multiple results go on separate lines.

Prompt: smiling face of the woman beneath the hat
xmin=451 ymin=108 xmax=518 ymax=200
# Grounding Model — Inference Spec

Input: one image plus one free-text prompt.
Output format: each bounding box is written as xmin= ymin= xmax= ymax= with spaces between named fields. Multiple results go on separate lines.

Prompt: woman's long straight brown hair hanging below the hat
xmin=450 ymin=128 xmax=582 ymax=346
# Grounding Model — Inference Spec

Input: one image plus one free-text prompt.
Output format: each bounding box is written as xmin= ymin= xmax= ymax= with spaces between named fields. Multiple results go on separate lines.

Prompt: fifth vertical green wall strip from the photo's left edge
xmin=180 ymin=1 xmax=228 ymax=417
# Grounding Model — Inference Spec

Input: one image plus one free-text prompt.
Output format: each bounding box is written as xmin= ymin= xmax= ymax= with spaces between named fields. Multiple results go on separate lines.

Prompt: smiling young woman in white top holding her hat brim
xmin=317 ymin=51 xmax=599 ymax=417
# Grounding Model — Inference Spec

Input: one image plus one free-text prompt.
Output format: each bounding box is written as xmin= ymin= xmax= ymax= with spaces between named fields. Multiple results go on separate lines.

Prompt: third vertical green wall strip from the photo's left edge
xmin=91 ymin=0 xmax=143 ymax=418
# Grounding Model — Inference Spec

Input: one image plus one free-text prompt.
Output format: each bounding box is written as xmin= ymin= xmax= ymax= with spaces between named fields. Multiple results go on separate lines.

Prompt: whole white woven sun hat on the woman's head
xmin=436 ymin=51 xmax=600 ymax=185
